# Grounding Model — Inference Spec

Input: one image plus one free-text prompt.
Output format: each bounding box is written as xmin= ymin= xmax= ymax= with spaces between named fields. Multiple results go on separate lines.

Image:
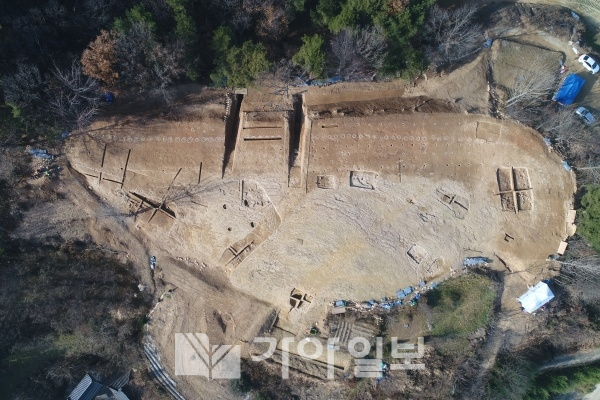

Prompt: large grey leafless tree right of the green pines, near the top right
xmin=425 ymin=3 xmax=484 ymax=63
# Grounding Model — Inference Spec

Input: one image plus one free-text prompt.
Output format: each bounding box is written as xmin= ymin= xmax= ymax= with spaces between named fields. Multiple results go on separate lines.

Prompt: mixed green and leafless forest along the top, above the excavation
xmin=0 ymin=0 xmax=466 ymax=143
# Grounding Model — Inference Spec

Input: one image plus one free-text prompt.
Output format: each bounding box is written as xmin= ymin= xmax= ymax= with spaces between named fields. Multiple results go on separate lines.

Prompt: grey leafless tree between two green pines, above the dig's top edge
xmin=331 ymin=27 xmax=387 ymax=80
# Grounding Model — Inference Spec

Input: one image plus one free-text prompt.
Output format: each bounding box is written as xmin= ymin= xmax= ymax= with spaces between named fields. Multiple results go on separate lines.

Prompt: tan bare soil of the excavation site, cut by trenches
xmin=61 ymin=65 xmax=574 ymax=398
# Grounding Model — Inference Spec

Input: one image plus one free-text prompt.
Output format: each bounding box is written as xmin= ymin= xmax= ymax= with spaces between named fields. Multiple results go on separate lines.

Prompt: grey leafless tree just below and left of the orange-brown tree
xmin=47 ymin=61 xmax=99 ymax=129
